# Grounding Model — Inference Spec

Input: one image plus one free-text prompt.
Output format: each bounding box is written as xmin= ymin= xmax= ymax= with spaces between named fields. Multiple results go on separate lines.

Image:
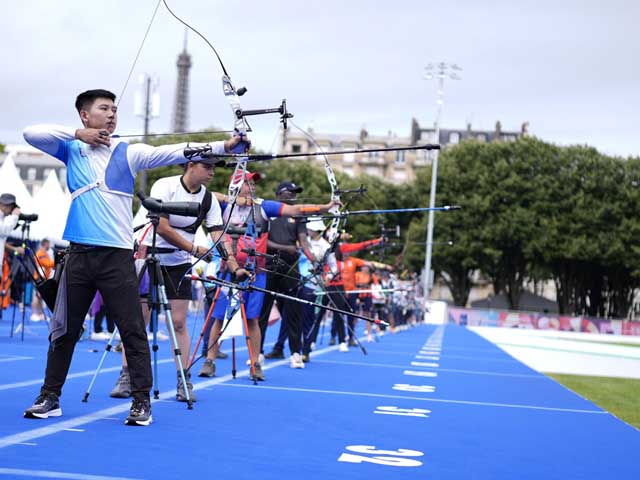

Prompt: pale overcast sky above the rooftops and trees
xmin=0 ymin=0 xmax=640 ymax=156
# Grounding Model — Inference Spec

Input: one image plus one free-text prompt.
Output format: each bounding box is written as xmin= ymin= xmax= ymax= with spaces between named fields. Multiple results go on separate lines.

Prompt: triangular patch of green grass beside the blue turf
xmin=545 ymin=373 xmax=640 ymax=429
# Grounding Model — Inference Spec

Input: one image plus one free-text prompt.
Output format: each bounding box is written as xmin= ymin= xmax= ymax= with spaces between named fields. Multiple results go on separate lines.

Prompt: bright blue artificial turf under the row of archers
xmin=0 ymin=311 xmax=640 ymax=480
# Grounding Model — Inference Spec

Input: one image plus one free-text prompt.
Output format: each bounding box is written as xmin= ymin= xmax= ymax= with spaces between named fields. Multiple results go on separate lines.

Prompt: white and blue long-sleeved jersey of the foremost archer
xmin=24 ymin=125 xmax=224 ymax=249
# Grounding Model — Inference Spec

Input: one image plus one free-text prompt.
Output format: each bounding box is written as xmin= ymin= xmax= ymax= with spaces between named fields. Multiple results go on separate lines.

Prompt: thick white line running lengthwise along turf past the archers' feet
xmin=0 ymin=345 xmax=338 ymax=446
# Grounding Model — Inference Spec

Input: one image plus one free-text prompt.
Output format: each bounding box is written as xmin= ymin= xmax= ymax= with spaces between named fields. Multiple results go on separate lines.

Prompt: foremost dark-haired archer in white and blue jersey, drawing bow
xmin=24 ymin=90 xmax=240 ymax=425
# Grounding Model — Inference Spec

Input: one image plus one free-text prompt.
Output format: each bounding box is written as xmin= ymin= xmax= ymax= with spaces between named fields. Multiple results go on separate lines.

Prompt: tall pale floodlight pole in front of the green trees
xmin=424 ymin=62 xmax=462 ymax=300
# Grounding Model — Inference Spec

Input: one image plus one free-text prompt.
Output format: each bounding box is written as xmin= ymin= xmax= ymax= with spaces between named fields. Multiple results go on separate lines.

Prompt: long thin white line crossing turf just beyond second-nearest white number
xmin=215 ymin=383 xmax=609 ymax=415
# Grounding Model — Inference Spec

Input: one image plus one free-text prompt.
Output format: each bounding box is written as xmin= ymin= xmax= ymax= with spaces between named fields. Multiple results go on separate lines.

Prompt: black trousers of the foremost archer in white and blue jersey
xmin=41 ymin=245 xmax=152 ymax=398
